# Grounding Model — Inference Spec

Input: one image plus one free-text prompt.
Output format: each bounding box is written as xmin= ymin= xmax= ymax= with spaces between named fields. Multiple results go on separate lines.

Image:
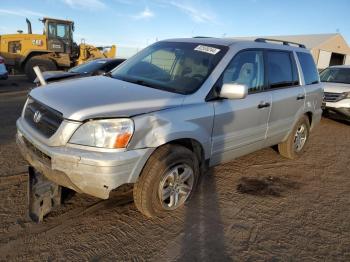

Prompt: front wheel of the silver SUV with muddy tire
xmin=133 ymin=145 xmax=200 ymax=218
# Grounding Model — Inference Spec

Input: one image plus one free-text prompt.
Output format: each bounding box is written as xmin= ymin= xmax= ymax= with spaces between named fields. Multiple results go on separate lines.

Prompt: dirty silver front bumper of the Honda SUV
xmin=16 ymin=121 xmax=154 ymax=199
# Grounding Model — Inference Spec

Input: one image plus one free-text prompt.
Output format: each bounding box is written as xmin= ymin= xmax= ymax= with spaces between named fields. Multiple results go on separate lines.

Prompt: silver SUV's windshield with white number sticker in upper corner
xmin=111 ymin=42 xmax=228 ymax=94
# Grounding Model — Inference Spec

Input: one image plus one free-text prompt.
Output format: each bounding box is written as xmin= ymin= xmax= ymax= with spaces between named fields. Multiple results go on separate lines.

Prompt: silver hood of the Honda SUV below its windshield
xmin=29 ymin=76 xmax=185 ymax=121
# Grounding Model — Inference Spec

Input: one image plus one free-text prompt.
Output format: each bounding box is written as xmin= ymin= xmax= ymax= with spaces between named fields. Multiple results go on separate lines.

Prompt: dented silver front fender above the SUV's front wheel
xmin=129 ymin=103 xmax=214 ymax=159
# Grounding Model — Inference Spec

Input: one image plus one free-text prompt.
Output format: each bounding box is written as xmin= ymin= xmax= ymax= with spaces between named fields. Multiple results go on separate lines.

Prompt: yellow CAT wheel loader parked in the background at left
xmin=0 ymin=17 xmax=116 ymax=80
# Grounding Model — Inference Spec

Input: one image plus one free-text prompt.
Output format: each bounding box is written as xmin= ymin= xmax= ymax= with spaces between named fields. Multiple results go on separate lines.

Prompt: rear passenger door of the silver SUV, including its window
xmin=265 ymin=50 xmax=305 ymax=146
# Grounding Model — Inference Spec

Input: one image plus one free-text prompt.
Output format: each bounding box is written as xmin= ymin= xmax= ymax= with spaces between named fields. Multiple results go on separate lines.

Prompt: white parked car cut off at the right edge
xmin=320 ymin=65 xmax=350 ymax=120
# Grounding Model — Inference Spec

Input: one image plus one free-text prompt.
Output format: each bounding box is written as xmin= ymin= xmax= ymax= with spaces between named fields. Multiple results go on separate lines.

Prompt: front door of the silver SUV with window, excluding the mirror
xmin=211 ymin=50 xmax=271 ymax=165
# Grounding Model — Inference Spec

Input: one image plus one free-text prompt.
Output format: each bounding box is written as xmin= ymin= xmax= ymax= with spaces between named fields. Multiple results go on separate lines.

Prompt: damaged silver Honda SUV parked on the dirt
xmin=17 ymin=38 xmax=323 ymax=220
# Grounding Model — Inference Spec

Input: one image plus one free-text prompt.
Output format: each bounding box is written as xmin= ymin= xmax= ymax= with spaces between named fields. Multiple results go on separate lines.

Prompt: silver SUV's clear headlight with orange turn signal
xmin=69 ymin=118 xmax=134 ymax=148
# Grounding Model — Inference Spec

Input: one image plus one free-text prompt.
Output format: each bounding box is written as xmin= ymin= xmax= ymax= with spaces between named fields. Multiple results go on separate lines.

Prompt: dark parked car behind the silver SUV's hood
xmin=34 ymin=58 xmax=125 ymax=86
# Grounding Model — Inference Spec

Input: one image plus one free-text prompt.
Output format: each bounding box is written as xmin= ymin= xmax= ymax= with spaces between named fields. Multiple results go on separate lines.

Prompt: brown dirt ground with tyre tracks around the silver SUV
xmin=0 ymin=77 xmax=350 ymax=261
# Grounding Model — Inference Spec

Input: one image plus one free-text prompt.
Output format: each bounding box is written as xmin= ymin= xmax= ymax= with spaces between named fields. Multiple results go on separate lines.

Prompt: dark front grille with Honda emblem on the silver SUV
xmin=24 ymin=98 xmax=63 ymax=138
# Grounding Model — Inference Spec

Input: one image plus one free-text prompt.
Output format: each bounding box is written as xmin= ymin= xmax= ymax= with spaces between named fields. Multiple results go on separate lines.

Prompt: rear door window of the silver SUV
xmin=267 ymin=51 xmax=299 ymax=88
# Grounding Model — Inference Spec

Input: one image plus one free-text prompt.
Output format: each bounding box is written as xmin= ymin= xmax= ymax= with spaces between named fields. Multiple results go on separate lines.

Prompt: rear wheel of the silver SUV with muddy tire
xmin=278 ymin=115 xmax=310 ymax=159
